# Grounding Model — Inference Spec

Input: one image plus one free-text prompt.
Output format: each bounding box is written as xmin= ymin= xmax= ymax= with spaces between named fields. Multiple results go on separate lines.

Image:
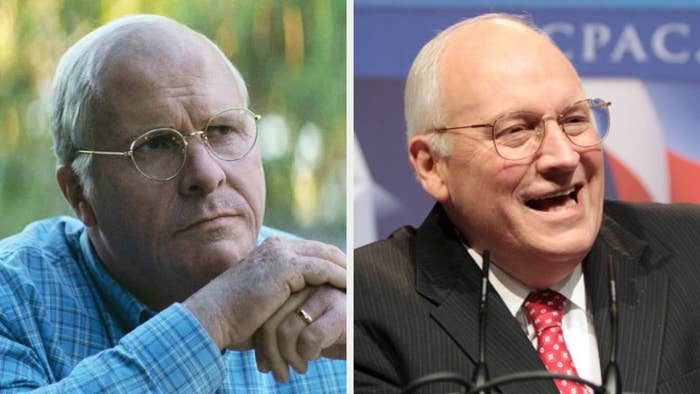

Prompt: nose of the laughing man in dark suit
xmin=536 ymin=118 xmax=581 ymax=173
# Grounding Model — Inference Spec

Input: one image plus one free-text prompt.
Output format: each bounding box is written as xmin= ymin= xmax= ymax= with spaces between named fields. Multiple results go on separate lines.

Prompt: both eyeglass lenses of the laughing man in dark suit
xmin=493 ymin=99 xmax=610 ymax=160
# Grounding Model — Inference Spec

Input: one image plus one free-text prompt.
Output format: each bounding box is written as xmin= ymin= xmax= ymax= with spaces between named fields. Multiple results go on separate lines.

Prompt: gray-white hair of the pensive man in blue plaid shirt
xmin=50 ymin=15 xmax=249 ymax=196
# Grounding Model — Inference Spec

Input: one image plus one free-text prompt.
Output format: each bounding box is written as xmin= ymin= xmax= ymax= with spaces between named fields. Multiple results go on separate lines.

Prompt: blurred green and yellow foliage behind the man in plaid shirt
xmin=0 ymin=0 xmax=346 ymax=250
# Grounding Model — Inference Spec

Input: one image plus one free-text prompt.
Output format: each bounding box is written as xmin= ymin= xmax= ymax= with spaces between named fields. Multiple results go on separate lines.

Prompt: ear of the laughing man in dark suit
xmin=408 ymin=134 xmax=450 ymax=203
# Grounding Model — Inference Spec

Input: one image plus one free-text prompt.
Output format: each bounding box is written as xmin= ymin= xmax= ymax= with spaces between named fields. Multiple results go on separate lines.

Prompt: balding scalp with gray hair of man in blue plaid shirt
xmin=51 ymin=15 xmax=248 ymax=194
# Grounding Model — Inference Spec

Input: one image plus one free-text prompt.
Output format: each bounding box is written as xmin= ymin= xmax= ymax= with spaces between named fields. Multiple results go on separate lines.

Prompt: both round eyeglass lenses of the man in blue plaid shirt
xmin=132 ymin=109 xmax=257 ymax=180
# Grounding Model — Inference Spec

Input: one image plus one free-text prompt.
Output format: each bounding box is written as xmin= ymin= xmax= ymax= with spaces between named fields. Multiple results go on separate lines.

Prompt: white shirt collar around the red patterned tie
xmin=464 ymin=244 xmax=587 ymax=316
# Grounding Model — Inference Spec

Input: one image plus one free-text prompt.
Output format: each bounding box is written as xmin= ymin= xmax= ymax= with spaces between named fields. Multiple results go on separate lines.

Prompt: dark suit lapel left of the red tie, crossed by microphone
xmin=415 ymin=204 xmax=557 ymax=393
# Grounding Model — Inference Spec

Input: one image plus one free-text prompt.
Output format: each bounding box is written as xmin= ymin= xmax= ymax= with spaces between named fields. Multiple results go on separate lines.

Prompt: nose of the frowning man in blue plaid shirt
xmin=179 ymin=132 xmax=226 ymax=195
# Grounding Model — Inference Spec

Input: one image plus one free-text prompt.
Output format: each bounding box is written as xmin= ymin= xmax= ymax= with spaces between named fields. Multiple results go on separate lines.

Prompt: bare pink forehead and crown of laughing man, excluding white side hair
xmin=438 ymin=18 xmax=579 ymax=125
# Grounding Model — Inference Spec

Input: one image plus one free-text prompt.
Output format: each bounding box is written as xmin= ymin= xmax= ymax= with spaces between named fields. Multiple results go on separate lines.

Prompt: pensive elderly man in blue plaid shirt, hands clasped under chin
xmin=0 ymin=15 xmax=346 ymax=393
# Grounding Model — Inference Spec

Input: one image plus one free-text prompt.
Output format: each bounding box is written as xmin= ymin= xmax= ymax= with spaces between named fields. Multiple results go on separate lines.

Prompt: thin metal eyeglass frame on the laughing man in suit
xmin=430 ymin=98 xmax=612 ymax=161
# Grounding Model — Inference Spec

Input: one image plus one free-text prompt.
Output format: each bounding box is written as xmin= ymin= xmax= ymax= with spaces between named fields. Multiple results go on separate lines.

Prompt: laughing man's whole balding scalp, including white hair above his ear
xmin=405 ymin=14 xmax=578 ymax=154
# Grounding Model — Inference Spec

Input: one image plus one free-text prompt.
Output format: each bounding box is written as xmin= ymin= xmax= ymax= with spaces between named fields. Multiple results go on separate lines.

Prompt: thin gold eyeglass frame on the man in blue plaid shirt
xmin=74 ymin=107 xmax=262 ymax=182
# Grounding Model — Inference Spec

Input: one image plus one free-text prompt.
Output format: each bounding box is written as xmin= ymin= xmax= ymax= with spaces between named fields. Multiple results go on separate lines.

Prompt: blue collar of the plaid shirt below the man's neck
xmin=80 ymin=229 xmax=155 ymax=332
